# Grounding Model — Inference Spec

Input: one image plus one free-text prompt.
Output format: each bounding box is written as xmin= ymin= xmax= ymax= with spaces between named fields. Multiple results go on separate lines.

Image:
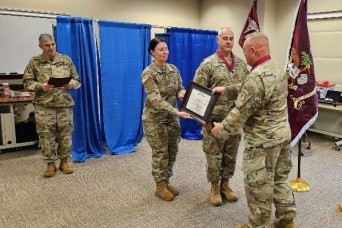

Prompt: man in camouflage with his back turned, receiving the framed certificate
xmin=211 ymin=33 xmax=296 ymax=228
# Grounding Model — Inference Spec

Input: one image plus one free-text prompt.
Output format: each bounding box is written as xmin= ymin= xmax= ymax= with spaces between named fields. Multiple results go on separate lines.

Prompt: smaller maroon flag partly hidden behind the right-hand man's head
xmin=239 ymin=0 xmax=260 ymax=47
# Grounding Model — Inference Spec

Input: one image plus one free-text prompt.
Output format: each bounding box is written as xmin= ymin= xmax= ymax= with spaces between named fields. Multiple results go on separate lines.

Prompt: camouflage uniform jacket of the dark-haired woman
xmin=141 ymin=62 xmax=185 ymax=120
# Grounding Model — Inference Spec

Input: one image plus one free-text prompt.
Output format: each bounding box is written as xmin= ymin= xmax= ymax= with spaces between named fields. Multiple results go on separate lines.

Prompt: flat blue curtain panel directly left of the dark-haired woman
xmin=99 ymin=21 xmax=151 ymax=154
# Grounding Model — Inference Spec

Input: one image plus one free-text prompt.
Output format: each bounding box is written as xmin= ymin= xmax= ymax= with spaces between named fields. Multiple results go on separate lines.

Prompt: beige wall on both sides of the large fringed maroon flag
xmin=272 ymin=0 xmax=342 ymax=84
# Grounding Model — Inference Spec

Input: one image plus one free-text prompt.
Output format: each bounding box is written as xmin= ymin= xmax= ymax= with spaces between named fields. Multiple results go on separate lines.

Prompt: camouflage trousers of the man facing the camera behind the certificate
xmin=202 ymin=128 xmax=241 ymax=182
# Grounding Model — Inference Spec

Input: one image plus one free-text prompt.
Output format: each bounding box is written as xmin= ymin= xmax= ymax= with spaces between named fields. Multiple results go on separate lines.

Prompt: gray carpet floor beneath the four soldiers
xmin=0 ymin=133 xmax=342 ymax=228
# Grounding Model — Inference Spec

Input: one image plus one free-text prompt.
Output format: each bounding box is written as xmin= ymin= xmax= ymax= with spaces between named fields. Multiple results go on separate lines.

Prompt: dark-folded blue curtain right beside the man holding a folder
xmin=56 ymin=17 xmax=105 ymax=162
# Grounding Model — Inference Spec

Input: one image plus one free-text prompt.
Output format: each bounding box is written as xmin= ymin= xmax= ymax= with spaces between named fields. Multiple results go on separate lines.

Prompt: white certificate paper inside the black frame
xmin=186 ymin=89 xmax=211 ymax=116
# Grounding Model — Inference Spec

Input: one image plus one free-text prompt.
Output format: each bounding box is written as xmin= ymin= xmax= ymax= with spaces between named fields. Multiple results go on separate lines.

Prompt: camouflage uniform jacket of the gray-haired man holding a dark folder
xmin=23 ymin=53 xmax=81 ymax=107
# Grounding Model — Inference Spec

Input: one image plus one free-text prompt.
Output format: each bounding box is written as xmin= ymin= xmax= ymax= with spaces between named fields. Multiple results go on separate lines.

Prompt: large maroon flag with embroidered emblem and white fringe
xmin=286 ymin=0 xmax=318 ymax=146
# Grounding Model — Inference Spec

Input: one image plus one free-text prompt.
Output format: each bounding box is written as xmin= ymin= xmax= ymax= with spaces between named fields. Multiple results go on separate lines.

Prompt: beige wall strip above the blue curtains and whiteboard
xmin=0 ymin=0 xmax=199 ymax=28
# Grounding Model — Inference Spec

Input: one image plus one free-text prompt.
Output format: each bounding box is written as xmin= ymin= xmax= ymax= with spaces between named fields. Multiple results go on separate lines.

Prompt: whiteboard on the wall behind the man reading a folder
xmin=0 ymin=15 xmax=56 ymax=74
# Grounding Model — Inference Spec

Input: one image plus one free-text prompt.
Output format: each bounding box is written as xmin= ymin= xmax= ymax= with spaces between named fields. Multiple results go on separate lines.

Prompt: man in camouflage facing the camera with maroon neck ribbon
xmin=194 ymin=28 xmax=248 ymax=206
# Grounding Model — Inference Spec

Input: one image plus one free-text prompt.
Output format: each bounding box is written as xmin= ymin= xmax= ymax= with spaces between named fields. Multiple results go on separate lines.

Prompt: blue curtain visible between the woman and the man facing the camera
xmin=169 ymin=28 xmax=217 ymax=140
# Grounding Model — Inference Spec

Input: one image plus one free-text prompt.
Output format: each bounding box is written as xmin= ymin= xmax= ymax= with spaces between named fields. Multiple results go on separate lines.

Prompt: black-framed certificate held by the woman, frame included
xmin=181 ymin=81 xmax=219 ymax=126
